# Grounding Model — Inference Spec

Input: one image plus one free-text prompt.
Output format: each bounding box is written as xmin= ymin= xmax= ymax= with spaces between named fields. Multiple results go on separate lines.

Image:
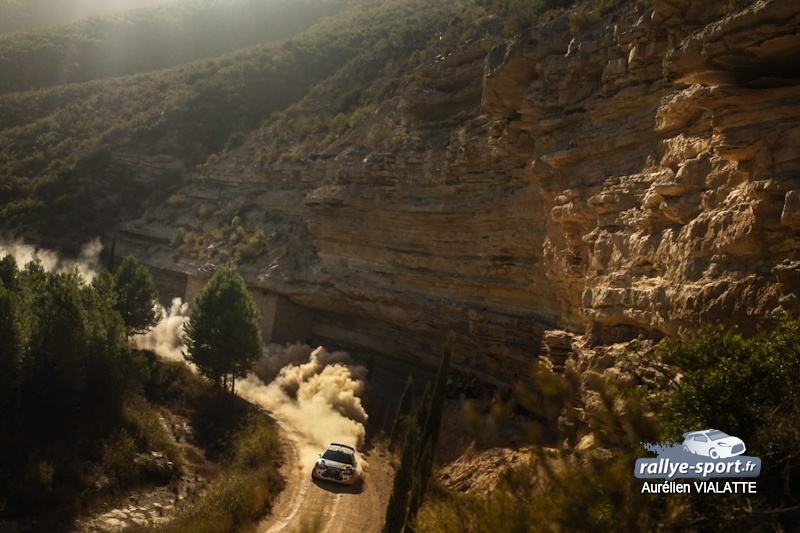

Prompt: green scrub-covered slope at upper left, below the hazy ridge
xmin=0 ymin=0 xmax=500 ymax=249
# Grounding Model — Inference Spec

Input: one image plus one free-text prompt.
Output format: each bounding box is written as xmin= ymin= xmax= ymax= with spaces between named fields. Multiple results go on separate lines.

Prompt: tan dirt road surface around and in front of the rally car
xmin=258 ymin=422 xmax=393 ymax=533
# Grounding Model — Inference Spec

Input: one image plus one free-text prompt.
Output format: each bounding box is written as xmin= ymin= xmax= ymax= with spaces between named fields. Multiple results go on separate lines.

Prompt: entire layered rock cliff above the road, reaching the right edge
xmin=121 ymin=0 xmax=800 ymax=381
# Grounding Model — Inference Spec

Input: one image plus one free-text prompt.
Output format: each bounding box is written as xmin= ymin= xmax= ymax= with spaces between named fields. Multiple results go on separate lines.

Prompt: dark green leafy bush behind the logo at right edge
xmin=655 ymin=315 xmax=800 ymax=530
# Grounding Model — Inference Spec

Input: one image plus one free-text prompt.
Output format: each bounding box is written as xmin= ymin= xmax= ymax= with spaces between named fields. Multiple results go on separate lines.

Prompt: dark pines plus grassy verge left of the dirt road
xmin=0 ymin=256 xmax=283 ymax=532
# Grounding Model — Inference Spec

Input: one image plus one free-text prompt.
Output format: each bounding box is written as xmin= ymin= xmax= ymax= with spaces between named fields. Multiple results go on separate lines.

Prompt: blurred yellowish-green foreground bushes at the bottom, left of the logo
xmin=415 ymin=367 xmax=683 ymax=533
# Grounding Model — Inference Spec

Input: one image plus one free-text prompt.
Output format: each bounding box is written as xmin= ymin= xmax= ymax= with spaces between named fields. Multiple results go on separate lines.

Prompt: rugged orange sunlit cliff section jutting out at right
xmin=484 ymin=0 xmax=800 ymax=343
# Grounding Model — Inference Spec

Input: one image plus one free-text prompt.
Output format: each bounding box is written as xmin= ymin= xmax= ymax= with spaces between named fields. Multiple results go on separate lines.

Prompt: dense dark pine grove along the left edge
xmin=0 ymin=256 xmax=162 ymax=515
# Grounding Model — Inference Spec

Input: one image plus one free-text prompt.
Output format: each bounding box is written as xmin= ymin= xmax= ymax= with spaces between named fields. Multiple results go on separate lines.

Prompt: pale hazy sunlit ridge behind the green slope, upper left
xmin=0 ymin=0 xmax=341 ymax=93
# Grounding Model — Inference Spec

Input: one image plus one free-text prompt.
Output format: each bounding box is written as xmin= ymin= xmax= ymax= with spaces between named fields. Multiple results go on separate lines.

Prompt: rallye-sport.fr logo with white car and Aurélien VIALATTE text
xmin=633 ymin=429 xmax=761 ymax=494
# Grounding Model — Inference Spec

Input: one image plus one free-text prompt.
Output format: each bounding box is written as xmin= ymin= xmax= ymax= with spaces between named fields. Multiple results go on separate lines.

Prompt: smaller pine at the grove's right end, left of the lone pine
xmin=114 ymin=257 xmax=161 ymax=336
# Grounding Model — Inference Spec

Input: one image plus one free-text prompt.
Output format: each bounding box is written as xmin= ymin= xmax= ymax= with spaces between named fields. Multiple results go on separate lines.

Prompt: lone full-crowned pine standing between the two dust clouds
xmin=183 ymin=268 xmax=262 ymax=392
